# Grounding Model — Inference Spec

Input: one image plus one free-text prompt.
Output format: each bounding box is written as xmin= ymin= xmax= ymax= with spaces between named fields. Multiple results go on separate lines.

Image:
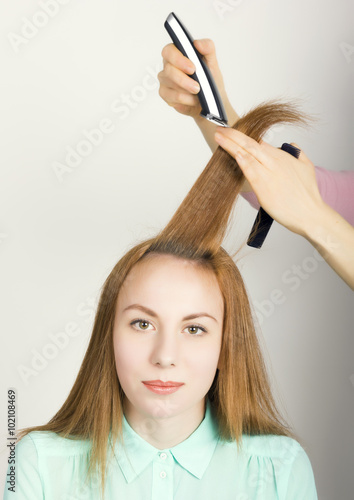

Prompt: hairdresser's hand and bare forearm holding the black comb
xmin=215 ymin=127 xmax=354 ymax=290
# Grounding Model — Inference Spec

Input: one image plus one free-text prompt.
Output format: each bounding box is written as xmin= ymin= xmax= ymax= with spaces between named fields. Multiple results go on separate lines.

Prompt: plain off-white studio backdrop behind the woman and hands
xmin=0 ymin=0 xmax=354 ymax=500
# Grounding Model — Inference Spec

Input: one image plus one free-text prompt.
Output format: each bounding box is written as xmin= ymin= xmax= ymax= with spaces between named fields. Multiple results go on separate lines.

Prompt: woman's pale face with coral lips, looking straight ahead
xmin=113 ymin=255 xmax=224 ymax=428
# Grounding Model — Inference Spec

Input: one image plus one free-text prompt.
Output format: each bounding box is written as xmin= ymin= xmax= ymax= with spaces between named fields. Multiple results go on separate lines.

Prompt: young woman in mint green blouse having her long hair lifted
xmin=4 ymin=103 xmax=317 ymax=500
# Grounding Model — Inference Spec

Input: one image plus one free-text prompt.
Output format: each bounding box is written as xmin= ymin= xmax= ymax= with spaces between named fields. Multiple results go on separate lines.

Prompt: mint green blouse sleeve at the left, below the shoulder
xmin=4 ymin=434 xmax=44 ymax=500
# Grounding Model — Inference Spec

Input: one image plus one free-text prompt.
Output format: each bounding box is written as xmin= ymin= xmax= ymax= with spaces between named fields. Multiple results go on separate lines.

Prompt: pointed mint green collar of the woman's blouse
xmin=115 ymin=398 xmax=219 ymax=483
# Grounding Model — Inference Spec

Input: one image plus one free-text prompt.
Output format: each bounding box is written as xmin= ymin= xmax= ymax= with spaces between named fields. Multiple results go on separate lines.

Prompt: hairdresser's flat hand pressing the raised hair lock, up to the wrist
xmin=215 ymin=127 xmax=324 ymax=236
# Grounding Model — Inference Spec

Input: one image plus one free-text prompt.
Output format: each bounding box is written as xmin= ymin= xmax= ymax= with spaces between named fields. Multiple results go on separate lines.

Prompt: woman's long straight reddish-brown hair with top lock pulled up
xmin=19 ymin=101 xmax=305 ymax=497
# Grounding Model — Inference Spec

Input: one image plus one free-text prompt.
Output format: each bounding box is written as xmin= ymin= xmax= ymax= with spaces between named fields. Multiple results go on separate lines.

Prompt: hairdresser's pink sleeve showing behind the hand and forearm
xmin=241 ymin=167 xmax=354 ymax=226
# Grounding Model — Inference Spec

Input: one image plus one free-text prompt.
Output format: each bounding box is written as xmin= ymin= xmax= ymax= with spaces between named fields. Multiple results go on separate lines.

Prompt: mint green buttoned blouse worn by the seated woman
xmin=4 ymin=401 xmax=317 ymax=500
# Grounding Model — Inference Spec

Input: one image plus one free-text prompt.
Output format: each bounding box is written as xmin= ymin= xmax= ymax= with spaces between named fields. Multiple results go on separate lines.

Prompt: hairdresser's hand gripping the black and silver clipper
xmin=157 ymin=38 xmax=238 ymax=152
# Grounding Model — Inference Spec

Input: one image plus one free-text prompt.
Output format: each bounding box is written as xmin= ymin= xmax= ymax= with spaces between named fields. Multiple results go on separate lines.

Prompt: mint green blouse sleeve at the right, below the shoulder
xmin=285 ymin=447 xmax=317 ymax=500
